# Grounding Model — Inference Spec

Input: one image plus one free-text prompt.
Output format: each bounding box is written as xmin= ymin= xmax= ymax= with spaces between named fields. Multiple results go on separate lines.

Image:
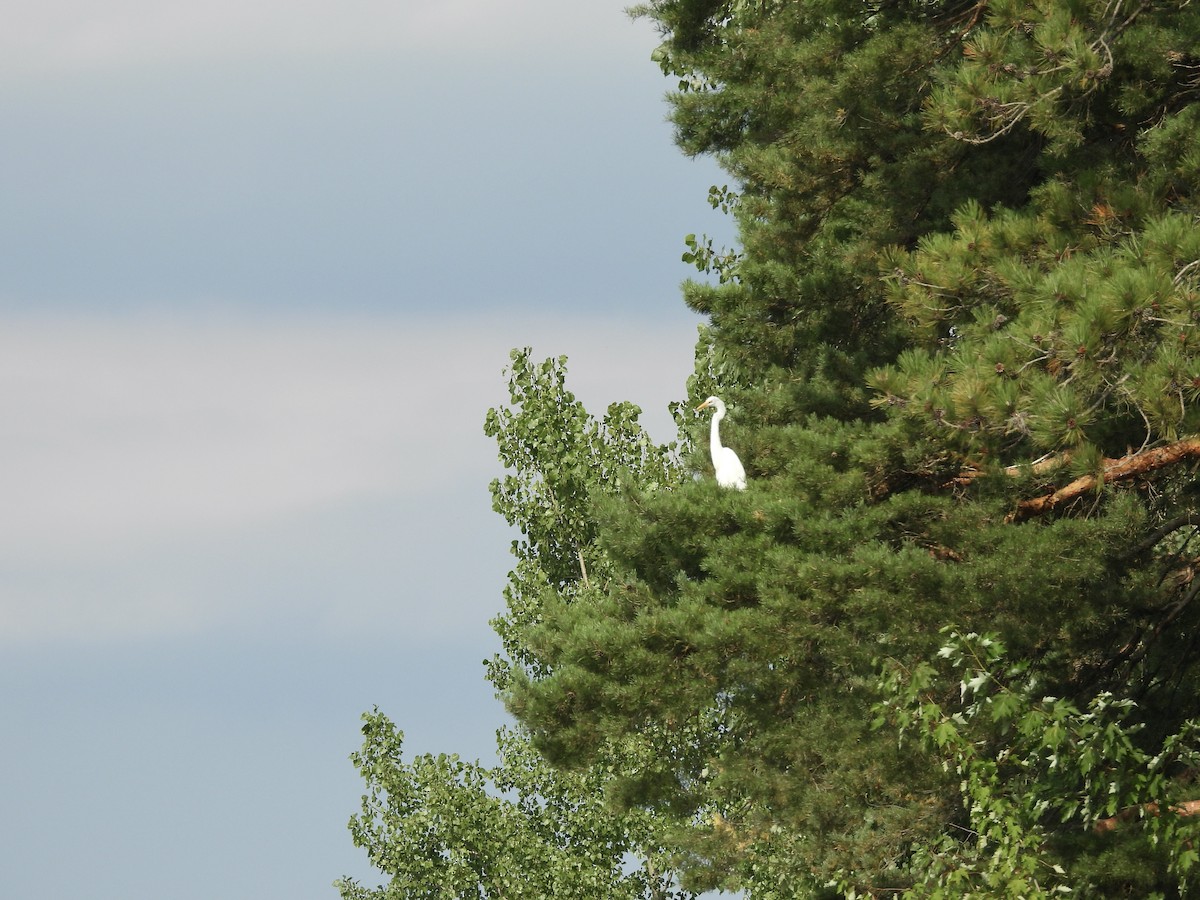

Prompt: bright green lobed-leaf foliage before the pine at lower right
xmin=876 ymin=628 xmax=1200 ymax=899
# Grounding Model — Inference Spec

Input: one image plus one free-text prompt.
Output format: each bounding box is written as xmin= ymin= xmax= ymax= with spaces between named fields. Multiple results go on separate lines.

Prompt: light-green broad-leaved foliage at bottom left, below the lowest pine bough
xmin=337 ymin=710 xmax=686 ymax=900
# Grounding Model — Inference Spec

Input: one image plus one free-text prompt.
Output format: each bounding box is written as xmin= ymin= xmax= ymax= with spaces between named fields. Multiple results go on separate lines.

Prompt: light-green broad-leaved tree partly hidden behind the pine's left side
xmin=338 ymin=349 xmax=691 ymax=900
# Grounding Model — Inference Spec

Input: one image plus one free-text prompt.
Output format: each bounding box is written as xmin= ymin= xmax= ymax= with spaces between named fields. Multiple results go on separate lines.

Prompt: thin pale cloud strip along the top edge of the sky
xmin=0 ymin=0 xmax=644 ymax=73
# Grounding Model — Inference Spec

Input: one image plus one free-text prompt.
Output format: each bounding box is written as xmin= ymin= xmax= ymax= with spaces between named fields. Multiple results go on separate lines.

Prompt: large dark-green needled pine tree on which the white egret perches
xmin=508 ymin=0 xmax=1200 ymax=896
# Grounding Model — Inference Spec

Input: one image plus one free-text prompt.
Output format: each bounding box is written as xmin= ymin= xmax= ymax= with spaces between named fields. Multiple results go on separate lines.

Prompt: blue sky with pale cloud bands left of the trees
xmin=0 ymin=0 xmax=728 ymax=900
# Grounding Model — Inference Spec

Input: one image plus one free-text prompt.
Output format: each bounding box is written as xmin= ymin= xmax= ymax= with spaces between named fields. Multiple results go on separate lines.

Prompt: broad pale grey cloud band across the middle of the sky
xmin=0 ymin=316 xmax=694 ymax=642
